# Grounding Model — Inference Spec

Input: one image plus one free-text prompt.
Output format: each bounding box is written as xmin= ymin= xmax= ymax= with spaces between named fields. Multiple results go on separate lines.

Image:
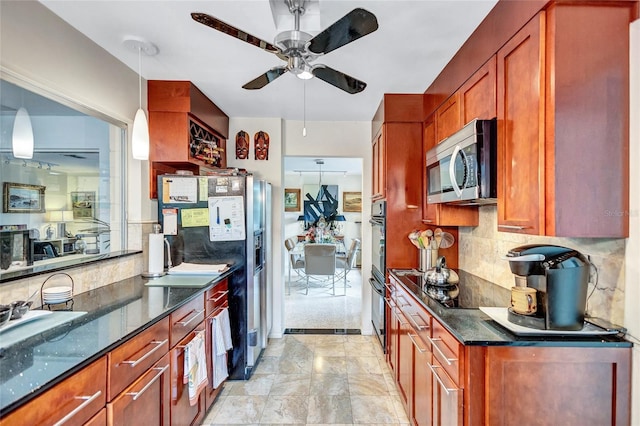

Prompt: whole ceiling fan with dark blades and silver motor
xmin=191 ymin=0 xmax=378 ymax=94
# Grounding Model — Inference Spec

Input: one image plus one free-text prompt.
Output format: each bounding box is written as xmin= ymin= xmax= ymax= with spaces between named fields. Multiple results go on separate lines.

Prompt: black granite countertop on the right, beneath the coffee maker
xmin=390 ymin=269 xmax=633 ymax=347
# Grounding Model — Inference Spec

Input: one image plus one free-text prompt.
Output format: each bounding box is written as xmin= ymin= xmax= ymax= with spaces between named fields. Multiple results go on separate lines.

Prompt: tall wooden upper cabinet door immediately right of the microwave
xmin=496 ymin=12 xmax=545 ymax=235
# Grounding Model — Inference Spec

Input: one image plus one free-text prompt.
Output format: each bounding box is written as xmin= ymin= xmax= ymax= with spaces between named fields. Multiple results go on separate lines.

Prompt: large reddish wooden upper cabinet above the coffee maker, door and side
xmin=496 ymin=2 xmax=633 ymax=238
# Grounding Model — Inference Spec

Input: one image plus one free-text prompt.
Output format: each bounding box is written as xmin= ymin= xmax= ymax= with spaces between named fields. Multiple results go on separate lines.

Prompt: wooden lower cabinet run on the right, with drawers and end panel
xmin=387 ymin=277 xmax=631 ymax=426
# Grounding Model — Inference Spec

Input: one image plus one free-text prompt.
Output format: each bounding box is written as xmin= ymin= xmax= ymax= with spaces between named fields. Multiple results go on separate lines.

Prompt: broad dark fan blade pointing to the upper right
xmin=309 ymin=8 xmax=378 ymax=54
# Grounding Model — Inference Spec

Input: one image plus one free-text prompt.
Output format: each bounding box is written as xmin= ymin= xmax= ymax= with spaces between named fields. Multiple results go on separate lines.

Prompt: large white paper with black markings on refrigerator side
xmin=208 ymin=195 xmax=246 ymax=241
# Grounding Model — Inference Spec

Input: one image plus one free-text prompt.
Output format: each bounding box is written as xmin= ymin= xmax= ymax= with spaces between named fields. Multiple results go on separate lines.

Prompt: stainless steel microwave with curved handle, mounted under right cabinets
xmin=426 ymin=118 xmax=497 ymax=205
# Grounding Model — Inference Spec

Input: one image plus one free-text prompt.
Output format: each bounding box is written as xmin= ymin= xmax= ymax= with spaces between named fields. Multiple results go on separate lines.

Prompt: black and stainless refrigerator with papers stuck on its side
xmin=158 ymin=169 xmax=271 ymax=380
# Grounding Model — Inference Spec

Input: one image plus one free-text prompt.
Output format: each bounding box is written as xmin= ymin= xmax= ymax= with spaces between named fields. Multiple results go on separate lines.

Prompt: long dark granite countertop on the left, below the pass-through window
xmin=0 ymin=268 xmax=235 ymax=416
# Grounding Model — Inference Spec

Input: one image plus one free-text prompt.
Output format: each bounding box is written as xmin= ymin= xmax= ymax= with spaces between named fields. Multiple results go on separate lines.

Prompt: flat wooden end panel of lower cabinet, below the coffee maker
xmin=485 ymin=346 xmax=631 ymax=426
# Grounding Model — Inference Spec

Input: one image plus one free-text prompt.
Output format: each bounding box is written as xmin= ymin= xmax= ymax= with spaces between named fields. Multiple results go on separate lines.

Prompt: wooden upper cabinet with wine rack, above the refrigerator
xmin=147 ymin=80 xmax=229 ymax=198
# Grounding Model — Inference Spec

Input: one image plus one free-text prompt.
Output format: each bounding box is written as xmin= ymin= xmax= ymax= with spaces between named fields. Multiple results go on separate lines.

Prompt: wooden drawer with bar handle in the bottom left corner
xmin=0 ymin=357 xmax=107 ymax=426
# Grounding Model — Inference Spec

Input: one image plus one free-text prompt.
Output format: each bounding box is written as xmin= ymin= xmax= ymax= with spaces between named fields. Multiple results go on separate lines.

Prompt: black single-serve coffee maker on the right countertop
xmin=506 ymin=245 xmax=590 ymax=331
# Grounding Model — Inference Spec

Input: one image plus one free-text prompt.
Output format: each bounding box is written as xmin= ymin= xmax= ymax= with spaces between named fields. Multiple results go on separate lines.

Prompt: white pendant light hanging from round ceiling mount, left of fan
xmin=124 ymin=37 xmax=158 ymax=160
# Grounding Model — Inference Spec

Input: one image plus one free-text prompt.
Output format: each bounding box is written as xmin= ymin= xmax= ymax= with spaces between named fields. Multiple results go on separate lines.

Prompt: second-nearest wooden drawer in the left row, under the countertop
xmin=107 ymin=317 xmax=169 ymax=401
